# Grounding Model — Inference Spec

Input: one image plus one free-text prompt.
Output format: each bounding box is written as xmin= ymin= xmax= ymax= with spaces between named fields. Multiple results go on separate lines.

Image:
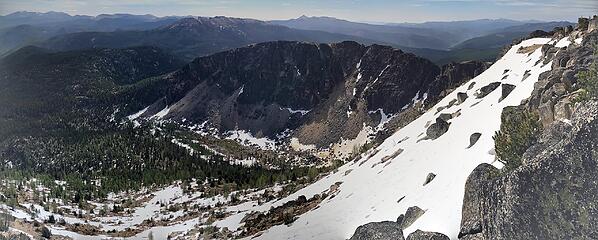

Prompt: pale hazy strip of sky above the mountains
xmin=0 ymin=0 xmax=598 ymax=22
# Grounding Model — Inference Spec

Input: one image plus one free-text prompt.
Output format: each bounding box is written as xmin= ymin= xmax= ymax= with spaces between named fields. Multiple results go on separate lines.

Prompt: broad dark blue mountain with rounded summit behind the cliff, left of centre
xmin=41 ymin=17 xmax=377 ymax=61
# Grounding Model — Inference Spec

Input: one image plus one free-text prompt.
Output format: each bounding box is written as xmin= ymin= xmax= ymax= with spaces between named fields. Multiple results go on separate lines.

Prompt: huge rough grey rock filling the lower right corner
xmin=460 ymin=102 xmax=598 ymax=239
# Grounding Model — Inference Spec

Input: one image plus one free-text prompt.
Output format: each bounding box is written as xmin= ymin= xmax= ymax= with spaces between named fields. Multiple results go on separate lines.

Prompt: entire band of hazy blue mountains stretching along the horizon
xmin=0 ymin=12 xmax=571 ymax=64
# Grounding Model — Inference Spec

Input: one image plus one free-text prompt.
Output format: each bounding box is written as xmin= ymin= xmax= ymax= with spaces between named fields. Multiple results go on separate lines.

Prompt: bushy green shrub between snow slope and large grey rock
xmin=493 ymin=107 xmax=541 ymax=171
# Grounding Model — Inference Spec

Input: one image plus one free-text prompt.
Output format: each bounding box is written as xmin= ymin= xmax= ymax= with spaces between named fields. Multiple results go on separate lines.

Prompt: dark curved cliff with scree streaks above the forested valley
xmin=132 ymin=42 xmax=440 ymax=149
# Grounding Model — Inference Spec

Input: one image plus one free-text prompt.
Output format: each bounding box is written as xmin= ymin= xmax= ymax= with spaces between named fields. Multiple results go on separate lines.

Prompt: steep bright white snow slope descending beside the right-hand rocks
xmin=218 ymin=38 xmax=564 ymax=239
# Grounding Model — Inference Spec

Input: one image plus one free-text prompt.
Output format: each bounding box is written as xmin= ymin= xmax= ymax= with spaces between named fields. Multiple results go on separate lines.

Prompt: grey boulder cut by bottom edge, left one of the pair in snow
xmin=350 ymin=221 xmax=405 ymax=240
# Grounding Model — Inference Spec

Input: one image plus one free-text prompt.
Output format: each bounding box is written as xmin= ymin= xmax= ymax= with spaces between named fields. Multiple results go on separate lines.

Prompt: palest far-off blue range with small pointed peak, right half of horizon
xmin=270 ymin=16 xmax=572 ymax=50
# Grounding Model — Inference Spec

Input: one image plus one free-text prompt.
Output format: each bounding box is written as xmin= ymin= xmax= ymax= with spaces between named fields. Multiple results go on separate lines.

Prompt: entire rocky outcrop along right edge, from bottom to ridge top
xmin=459 ymin=23 xmax=598 ymax=239
